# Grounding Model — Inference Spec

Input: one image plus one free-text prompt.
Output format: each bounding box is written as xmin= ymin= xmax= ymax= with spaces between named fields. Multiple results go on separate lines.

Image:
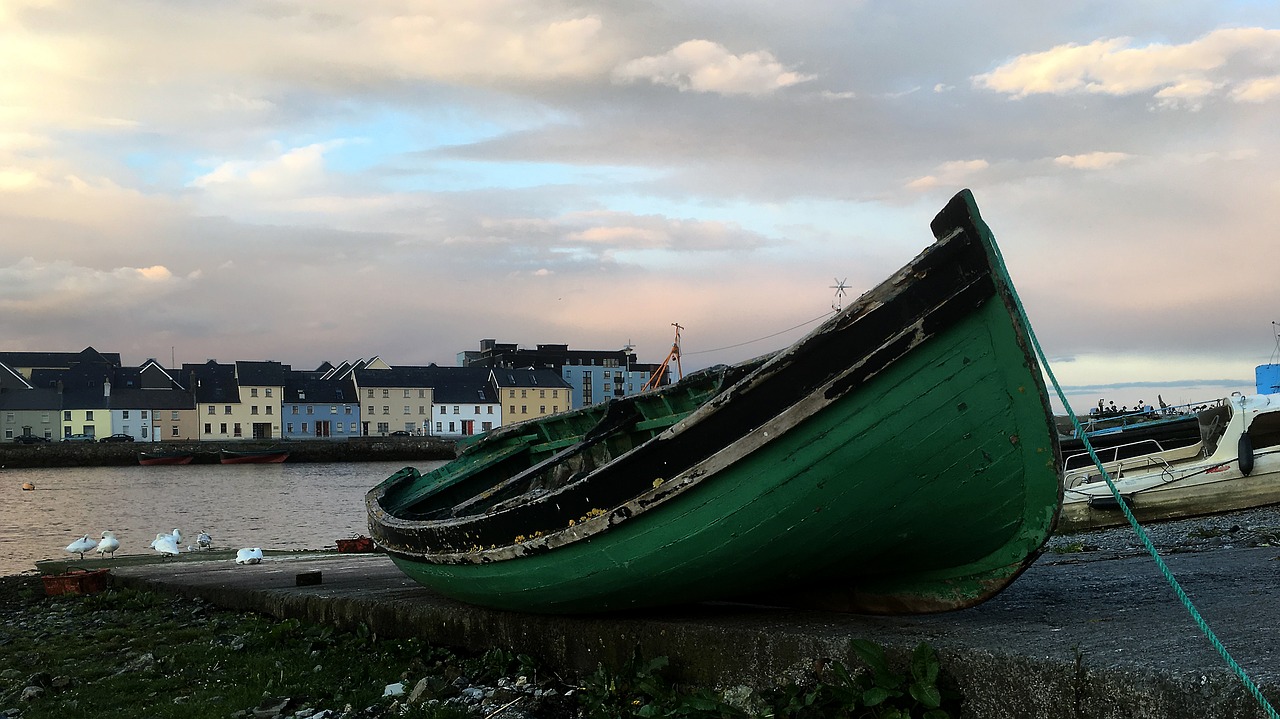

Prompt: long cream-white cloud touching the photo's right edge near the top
xmin=973 ymin=28 xmax=1280 ymax=106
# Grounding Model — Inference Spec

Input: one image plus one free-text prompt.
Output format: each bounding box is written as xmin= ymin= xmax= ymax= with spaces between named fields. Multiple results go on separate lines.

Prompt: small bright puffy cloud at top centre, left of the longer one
xmin=613 ymin=40 xmax=815 ymax=96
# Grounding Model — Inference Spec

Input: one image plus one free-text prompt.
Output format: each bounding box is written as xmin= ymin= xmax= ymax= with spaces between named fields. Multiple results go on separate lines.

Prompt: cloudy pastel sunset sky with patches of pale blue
xmin=0 ymin=0 xmax=1280 ymax=412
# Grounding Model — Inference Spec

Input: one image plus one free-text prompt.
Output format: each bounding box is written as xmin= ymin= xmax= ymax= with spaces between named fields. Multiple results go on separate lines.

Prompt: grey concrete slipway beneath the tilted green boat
xmin=97 ymin=546 xmax=1280 ymax=719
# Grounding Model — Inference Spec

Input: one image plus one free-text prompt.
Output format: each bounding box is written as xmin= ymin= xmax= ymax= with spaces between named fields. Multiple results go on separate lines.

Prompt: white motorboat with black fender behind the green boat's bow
xmin=1059 ymin=394 xmax=1280 ymax=533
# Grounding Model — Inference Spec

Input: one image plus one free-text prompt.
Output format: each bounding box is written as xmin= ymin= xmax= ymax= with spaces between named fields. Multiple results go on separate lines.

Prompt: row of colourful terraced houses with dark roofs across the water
xmin=0 ymin=340 xmax=659 ymax=443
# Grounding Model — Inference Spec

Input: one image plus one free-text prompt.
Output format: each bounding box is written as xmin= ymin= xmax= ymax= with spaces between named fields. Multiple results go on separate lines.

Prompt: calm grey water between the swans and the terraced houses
xmin=0 ymin=462 xmax=440 ymax=574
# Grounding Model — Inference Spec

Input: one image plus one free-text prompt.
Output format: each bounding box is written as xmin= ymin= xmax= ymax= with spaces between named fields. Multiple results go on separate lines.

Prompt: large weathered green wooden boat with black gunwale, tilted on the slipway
xmin=366 ymin=191 xmax=1062 ymax=613
